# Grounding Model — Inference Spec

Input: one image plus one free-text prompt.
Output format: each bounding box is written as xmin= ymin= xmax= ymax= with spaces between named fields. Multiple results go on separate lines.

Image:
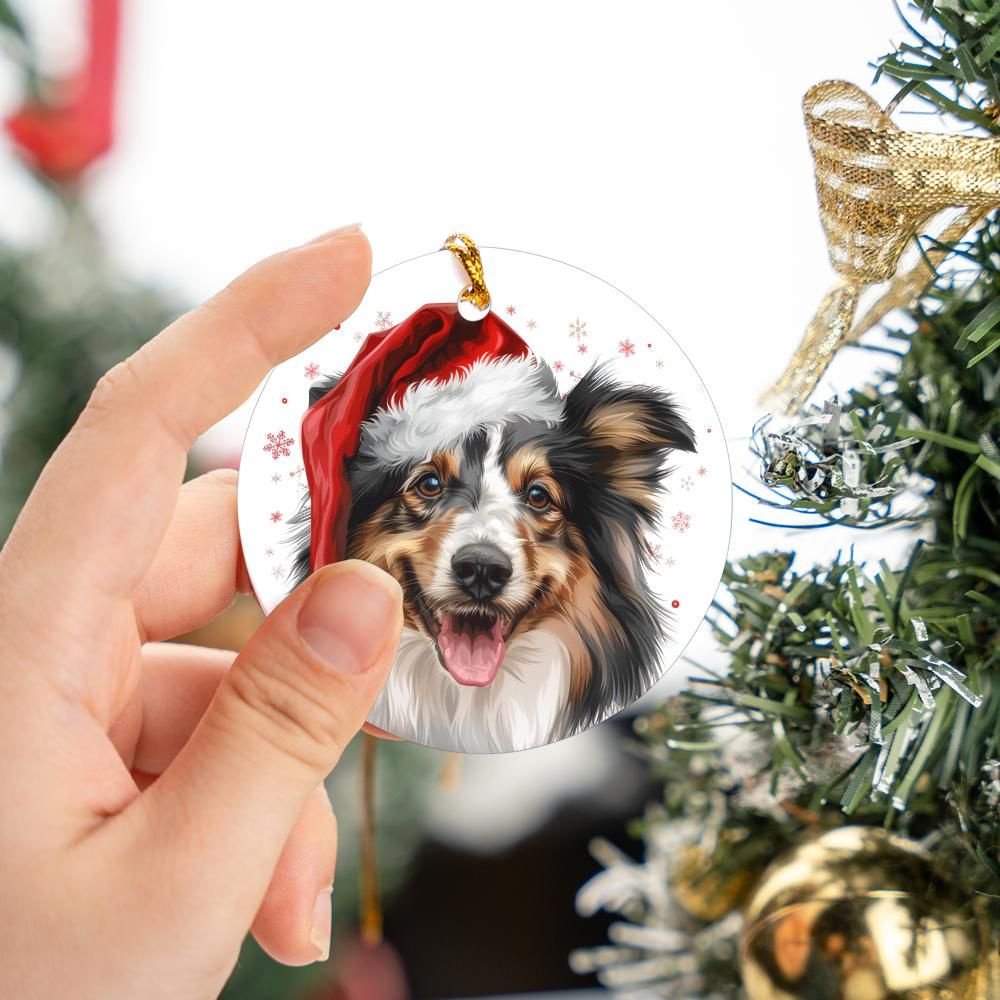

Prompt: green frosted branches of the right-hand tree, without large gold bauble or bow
xmin=588 ymin=0 xmax=1000 ymax=998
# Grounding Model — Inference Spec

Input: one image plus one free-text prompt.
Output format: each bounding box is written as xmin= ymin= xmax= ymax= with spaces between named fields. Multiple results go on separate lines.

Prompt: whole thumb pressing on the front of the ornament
xmin=139 ymin=561 xmax=402 ymax=916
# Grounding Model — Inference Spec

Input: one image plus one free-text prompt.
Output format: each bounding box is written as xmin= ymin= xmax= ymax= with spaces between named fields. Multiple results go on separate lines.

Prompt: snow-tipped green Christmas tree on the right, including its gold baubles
xmin=573 ymin=0 xmax=1000 ymax=1000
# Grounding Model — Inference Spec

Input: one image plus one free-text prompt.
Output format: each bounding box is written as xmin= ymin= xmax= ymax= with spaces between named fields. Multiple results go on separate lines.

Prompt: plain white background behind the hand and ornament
xmin=0 ymin=0 xmax=925 ymax=844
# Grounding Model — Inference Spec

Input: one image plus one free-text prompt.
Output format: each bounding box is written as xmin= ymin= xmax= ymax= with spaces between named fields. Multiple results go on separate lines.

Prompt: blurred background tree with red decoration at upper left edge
xmin=0 ymin=0 xmax=180 ymax=543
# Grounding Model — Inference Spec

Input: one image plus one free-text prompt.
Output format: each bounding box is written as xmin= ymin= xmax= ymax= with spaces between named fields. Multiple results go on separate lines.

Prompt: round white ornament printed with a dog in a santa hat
xmin=239 ymin=242 xmax=731 ymax=753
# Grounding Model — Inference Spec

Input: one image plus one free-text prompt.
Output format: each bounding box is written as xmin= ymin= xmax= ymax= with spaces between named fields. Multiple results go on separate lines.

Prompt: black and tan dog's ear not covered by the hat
xmin=566 ymin=367 xmax=695 ymax=512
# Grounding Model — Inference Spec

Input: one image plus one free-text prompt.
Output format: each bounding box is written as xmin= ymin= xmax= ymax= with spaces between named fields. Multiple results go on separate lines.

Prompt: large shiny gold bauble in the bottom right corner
xmin=741 ymin=827 xmax=1000 ymax=1000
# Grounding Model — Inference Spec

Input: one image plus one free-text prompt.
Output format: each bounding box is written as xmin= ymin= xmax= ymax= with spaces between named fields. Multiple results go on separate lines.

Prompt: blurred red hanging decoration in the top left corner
xmin=5 ymin=0 xmax=121 ymax=182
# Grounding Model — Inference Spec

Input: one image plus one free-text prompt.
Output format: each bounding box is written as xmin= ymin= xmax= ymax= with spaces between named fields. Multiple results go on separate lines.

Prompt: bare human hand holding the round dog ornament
xmin=0 ymin=227 xmax=402 ymax=1000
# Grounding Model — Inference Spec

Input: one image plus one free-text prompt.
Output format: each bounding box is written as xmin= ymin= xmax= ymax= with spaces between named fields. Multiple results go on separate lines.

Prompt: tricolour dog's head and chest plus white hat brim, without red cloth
xmin=296 ymin=359 xmax=694 ymax=752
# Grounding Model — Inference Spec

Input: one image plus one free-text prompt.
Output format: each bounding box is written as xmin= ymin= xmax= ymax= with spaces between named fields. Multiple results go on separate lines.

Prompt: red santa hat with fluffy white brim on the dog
xmin=301 ymin=303 xmax=561 ymax=571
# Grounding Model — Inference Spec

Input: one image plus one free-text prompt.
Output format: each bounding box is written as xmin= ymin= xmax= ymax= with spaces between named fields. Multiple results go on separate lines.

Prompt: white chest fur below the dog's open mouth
xmin=369 ymin=628 xmax=569 ymax=753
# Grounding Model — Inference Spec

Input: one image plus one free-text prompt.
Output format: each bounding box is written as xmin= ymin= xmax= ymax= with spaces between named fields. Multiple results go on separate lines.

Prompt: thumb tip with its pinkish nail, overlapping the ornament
xmin=299 ymin=561 xmax=402 ymax=674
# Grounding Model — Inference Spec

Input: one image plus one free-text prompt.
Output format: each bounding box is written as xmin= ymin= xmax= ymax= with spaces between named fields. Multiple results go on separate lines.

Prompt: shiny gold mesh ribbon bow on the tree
xmin=769 ymin=81 xmax=1000 ymax=412
